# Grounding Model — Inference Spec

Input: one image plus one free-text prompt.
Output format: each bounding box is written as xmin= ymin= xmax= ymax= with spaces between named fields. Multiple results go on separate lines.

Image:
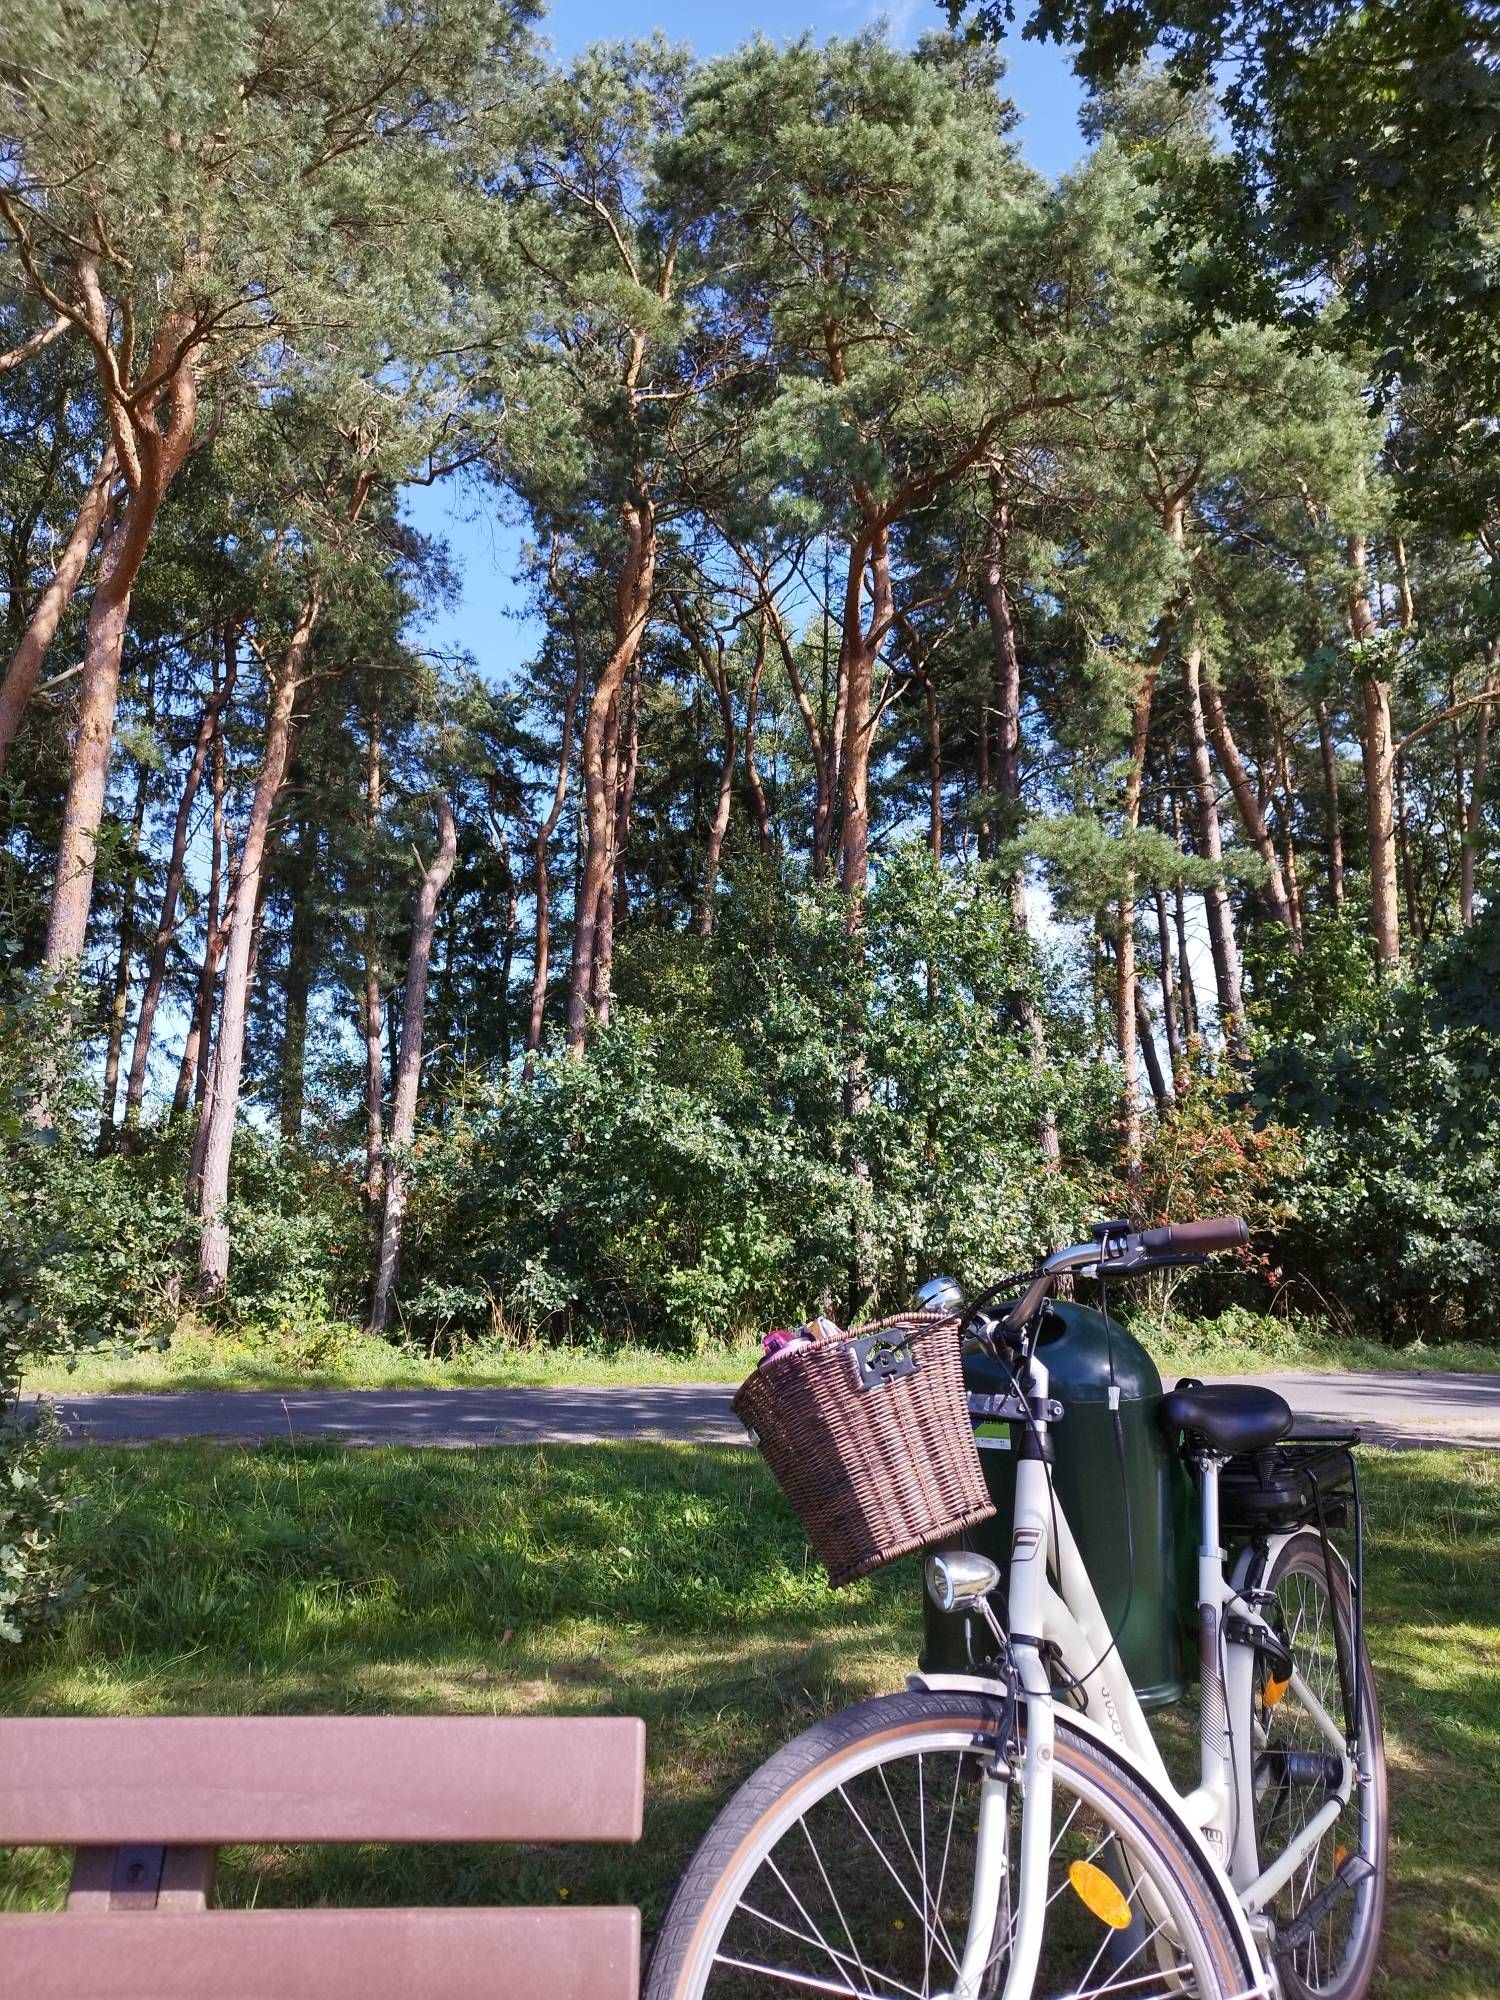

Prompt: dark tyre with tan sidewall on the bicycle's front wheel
xmin=646 ymin=1692 xmax=1260 ymax=2000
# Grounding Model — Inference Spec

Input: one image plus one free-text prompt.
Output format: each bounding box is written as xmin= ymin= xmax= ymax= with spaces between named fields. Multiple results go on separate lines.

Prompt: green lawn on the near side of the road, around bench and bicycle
xmin=0 ymin=1444 xmax=1500 ymax=2000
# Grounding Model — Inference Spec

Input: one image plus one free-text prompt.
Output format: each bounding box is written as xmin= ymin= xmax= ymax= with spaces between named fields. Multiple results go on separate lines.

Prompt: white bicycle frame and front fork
xmin=920 ymin=1360 xmax=1356 ymax=2000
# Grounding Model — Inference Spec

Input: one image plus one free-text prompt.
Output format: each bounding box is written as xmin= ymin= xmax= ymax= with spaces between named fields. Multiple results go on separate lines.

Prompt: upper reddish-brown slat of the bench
xmin=0 ymin=1716 xmax=646 ymax=1846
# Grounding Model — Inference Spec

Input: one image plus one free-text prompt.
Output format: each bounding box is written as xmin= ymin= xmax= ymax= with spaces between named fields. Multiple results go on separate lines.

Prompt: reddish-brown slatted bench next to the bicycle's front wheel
xmin=0 ymin=1716 xmax=646 ymax=2000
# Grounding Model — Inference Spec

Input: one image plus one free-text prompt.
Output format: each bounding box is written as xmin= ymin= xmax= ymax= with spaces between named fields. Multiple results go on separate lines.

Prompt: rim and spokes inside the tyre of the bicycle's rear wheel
xmin=1254 ymin=1556 xmax=1380 ymax=1992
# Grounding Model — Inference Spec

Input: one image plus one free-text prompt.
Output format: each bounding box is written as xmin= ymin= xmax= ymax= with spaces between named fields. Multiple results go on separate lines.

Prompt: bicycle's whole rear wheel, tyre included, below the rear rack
xmin=1252 ymin=1530 xmax=1386 ymax=2000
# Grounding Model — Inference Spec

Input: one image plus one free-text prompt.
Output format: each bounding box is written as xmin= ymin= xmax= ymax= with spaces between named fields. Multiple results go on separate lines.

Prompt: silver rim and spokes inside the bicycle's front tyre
xmin=686 ymin=1724 xmax=1248 ymax=2000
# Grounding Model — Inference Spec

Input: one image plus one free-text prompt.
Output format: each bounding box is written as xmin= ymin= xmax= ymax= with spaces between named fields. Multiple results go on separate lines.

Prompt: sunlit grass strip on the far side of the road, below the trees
xmin=24 ymin=1318 xmax=1500 ymax=1394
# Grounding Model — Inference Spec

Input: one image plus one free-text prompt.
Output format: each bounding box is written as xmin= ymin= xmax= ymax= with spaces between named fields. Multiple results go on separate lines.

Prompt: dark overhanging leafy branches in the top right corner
xmin=980 ymin=0 xmax=1500 ymax=528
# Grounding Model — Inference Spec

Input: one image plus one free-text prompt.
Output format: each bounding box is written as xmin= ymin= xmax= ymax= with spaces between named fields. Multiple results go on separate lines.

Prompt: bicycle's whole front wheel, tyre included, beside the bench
xmin=646 ymin=1692 xmax=1256 ymax=2000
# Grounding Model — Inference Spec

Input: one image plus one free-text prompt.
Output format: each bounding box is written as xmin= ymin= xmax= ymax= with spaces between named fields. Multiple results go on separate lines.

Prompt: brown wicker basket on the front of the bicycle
xmin=734 ymin=1312 xmax=994 ymax=1584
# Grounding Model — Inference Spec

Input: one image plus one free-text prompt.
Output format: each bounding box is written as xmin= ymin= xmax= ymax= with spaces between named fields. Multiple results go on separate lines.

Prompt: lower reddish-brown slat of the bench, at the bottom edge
xmin=0 ymin=1908 xmax=640 ymax=2000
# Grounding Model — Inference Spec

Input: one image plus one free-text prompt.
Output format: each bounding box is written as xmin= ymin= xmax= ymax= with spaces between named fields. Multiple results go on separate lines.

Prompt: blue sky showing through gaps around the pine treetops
xmin=406 ymin=0 xmax=1084 ymax=680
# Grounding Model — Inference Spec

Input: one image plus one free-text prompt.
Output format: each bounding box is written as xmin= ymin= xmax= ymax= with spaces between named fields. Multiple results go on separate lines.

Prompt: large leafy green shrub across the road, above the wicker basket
xmin=406 ymin=850 xmax=1098 ymax=1348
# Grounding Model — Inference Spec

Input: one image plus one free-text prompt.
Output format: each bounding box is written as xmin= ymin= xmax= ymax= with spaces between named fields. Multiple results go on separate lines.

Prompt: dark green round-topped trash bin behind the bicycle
xmin=920 ymin=1300 xmax=1196 ymax=1710
